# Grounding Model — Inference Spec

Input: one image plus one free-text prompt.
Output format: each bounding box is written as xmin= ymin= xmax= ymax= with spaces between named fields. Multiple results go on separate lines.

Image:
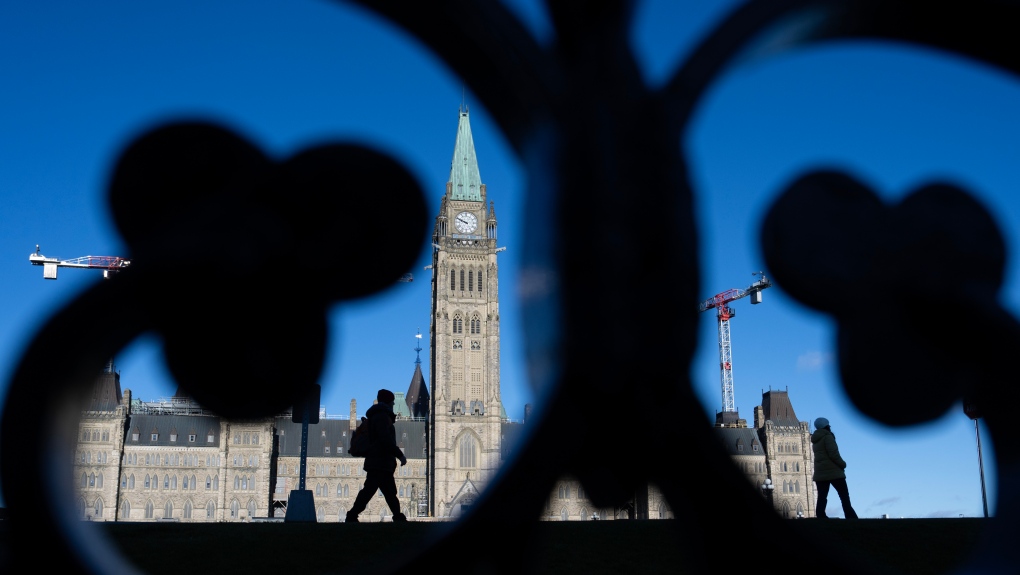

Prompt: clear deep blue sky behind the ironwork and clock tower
xmin=0 ymin=0 xmax=1020 ymax=517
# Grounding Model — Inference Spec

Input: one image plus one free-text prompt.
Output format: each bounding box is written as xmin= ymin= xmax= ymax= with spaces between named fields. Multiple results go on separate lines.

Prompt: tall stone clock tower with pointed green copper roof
xmin=428 ymin=108 xmax=503 ymax=517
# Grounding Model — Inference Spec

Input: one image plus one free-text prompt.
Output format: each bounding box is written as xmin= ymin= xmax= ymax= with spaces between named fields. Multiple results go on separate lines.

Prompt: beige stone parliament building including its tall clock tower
xmin=72 ymin=110 xmax=815 ymax=522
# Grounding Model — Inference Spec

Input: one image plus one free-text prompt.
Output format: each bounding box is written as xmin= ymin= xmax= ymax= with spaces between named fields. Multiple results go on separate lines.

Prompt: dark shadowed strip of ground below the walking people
xmin=0 ymin=519 xmax=993 ymax=575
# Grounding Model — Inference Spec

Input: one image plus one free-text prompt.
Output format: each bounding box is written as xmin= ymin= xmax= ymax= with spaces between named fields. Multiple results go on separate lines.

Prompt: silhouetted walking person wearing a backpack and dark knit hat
xmin=347 ymin=389 xmax=407 ymax=523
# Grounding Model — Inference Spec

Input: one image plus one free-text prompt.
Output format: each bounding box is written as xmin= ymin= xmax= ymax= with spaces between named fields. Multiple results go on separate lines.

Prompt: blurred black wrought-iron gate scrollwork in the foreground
xmin=0 ymin=0 xmax=1020 ymax=573
